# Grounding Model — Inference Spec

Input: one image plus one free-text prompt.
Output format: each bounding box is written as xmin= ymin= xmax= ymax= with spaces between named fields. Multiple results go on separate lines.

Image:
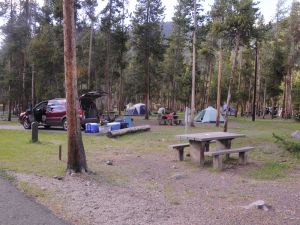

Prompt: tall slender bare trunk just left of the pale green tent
xmin=190 ymin=0 xmax=197 ymax=127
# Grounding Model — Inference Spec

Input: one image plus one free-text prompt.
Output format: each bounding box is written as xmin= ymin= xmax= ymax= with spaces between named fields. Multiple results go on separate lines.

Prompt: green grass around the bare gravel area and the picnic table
xmin=0 ymin=117 xmax=300 ymax=180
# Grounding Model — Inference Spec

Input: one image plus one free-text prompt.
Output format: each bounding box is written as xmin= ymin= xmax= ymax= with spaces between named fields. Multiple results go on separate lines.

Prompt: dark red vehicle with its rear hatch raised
xmin=19 ymin=91 xmax=106 ymax=130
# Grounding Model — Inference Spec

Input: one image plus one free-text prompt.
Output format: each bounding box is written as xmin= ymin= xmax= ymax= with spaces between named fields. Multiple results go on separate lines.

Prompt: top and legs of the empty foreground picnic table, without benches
xmin=177 ymin=132 xmax=246 ymax=166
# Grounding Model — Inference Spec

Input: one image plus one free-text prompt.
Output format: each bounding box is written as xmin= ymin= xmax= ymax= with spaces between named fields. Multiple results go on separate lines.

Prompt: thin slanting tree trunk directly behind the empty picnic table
xmin=224 ymin=32 xmax=240 ymax=132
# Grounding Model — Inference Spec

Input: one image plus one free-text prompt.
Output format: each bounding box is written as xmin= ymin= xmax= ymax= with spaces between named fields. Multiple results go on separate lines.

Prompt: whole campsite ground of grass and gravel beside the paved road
xmin=0 ymin=117 xmax=300 ymax=225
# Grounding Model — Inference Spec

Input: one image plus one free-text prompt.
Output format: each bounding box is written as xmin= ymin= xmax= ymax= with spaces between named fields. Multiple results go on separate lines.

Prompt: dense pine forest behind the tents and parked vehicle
xmin=0 ymin=0 xmax=300 ymax=120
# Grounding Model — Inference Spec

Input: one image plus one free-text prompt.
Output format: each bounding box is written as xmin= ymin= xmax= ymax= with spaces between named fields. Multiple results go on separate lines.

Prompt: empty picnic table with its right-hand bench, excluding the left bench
xmin=177 ymin=132 xmax=254 ymax=168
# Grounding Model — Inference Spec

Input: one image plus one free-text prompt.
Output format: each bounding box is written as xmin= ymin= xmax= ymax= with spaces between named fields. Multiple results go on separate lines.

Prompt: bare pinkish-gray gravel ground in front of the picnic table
xmin=12 ymin=154 xmax=300 ymax=225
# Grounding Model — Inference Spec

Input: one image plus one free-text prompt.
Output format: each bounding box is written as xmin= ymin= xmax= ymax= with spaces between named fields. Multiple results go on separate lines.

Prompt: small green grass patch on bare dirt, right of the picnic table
xmin=249 ymin=162 xmax=291 ymax=180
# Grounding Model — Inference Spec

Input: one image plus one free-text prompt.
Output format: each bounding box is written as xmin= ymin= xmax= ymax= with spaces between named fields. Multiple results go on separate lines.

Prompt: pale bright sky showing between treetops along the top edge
xmin=125 ymin=0 xmax=292 ymax=22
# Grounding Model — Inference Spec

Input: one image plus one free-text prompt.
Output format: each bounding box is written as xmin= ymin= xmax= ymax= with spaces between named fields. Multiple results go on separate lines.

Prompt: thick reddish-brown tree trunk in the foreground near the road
xmin=63 ymin=0 xmax=87 ymax=173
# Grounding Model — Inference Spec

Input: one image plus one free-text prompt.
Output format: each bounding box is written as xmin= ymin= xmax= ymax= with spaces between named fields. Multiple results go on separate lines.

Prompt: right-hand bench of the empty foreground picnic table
xmin=204 ymin=146 xmax=254 ymax=170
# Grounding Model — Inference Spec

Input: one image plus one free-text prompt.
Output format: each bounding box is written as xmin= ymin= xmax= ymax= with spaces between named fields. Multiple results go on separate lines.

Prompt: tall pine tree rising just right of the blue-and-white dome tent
xmin=132 ymin=0 xmax=164 ymax=119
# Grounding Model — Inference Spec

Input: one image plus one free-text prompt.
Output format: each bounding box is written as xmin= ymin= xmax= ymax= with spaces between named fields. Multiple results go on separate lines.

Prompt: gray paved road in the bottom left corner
xmin=0 ymin=178 xmax=71 ymax=225
